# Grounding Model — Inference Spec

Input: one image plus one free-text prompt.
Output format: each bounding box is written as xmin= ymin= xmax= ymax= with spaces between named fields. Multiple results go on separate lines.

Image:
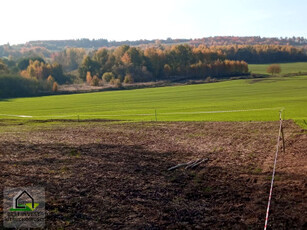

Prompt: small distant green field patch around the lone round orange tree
xmin=248 ymin=62 xmax=307 ymax=74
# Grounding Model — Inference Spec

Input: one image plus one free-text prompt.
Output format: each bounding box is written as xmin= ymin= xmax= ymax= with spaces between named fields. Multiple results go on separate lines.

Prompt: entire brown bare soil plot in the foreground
xmin=0 ymin=121 xmax=307 ymax=229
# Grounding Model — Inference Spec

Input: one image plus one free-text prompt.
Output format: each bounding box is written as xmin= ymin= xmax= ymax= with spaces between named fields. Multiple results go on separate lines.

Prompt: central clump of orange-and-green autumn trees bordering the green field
xmin=79 ymin=45 xmax=248 ymax=82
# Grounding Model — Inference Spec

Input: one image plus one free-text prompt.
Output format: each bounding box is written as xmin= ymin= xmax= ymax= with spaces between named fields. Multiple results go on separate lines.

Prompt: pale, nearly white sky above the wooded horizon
xmin=0 ymin=0 xmax=307 ymax=45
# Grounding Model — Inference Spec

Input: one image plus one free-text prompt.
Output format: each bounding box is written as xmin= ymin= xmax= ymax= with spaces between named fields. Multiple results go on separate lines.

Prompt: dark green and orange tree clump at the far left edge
xmin=0 ymin=57 xmax=73 ymax=98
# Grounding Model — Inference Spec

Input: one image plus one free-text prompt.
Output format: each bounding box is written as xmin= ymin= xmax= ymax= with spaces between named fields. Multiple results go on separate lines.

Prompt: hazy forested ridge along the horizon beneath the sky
xmin=0 ymin=36 xmax=307 ymax=52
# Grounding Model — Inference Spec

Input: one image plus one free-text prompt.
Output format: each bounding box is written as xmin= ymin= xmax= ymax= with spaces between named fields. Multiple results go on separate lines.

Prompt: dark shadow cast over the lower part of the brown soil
xmin=0 ymin=139 xmax=304 ymax=229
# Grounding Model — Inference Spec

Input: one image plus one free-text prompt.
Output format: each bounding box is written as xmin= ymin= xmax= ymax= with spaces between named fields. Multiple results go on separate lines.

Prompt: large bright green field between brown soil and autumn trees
xmin=0 ymin=76 xmax=307 ymax=126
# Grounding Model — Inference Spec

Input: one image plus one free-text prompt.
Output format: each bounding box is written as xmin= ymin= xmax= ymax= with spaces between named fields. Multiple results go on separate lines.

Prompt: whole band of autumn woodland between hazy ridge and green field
xmin=0 ymin=39 xmax=307 ymax=97
